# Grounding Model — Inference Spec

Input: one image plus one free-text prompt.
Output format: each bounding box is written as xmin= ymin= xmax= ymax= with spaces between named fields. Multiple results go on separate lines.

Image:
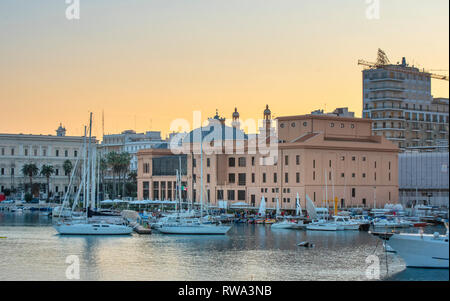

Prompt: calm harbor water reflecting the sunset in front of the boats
xmin=0 ymin=212 xmax=449 ymax=281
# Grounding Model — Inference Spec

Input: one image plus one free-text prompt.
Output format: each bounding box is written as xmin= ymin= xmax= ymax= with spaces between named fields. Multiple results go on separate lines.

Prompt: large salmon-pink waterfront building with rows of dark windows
xmin=138 ymin=107 xmax=399 ymax=209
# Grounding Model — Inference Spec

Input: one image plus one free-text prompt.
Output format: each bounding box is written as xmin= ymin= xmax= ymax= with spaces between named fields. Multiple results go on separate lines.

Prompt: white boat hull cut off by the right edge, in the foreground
xmin=387 ymin=234 xmax=449 ymax=269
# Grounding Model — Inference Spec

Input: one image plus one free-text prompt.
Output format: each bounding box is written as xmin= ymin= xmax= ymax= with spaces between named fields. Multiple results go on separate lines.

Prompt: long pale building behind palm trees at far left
xmin=0 ymin=125 xmax=96 ymax=196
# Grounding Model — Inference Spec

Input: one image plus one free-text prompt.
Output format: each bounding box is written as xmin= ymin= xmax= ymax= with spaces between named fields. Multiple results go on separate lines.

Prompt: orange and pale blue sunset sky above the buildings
xmin=0 ymin=0 xmax=449 ymax=137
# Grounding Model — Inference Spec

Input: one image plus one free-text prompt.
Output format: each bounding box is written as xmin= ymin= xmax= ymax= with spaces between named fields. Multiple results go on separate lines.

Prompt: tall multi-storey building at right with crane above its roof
xmin=362 ymin=58 xmax=449 ymax=150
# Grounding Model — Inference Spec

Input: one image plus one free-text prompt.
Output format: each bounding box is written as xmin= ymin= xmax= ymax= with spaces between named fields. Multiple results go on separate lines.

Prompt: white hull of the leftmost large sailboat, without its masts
xmin=54 ymin=224 xmax=133 ymax=235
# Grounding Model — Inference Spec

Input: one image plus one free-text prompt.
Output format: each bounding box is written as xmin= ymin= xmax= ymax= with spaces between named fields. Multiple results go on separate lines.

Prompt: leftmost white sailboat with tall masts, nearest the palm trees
xmin=54 ymin=113 xmax=133 ymax=235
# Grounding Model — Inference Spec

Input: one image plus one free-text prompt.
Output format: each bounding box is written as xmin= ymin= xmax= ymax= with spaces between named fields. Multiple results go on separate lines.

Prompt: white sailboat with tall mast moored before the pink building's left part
xmin=158 ymin=126 xmax=231 ymax=235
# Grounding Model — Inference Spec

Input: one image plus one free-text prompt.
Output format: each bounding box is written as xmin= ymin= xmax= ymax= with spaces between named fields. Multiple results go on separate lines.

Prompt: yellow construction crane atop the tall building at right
xmin=358 ymin=49 xmax=448 ymax=81
